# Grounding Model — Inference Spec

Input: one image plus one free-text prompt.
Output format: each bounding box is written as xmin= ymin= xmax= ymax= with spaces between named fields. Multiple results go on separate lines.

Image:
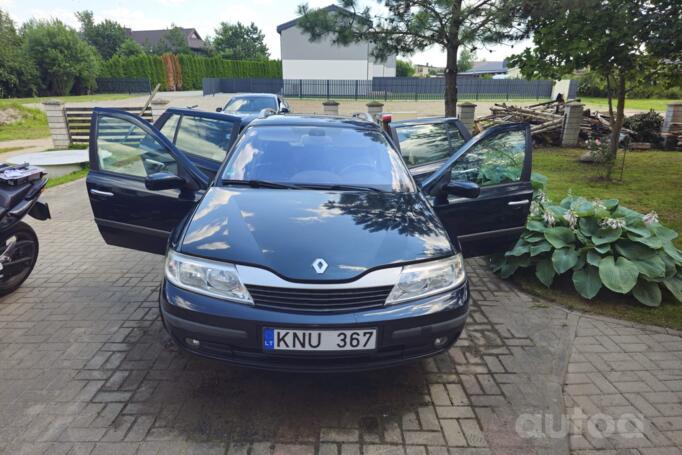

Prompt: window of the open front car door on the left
xmin=97 ymin=116 xmax=178 ymax=178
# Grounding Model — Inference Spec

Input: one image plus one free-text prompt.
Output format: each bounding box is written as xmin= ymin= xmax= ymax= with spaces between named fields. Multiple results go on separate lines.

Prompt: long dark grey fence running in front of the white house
xmin=203 ymin=76 xmax=577 ymax=100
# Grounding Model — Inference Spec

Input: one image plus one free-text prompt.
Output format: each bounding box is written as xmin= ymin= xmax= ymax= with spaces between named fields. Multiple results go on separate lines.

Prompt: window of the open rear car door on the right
xmin=396 ymin=122 xmax=465 ymax=167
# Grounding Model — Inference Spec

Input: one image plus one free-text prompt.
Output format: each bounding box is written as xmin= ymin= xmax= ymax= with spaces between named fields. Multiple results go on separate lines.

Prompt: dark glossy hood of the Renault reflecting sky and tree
xmin=178 ymin=187 xmax=453 ymax=281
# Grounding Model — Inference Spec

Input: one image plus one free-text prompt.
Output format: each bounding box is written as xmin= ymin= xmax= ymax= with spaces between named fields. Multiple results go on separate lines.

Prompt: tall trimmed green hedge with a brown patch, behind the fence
xmin=99 ymin=55 xmax=282 ymax=90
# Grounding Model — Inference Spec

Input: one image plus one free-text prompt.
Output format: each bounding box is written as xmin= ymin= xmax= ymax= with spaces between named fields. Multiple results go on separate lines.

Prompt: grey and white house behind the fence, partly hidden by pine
xmin=277 ymin=5 xmax=396 ymax=80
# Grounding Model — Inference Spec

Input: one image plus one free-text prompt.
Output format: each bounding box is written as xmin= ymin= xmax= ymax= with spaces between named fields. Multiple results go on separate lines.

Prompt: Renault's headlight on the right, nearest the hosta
xmin=386 ymin=254 xmax=466 ymax=305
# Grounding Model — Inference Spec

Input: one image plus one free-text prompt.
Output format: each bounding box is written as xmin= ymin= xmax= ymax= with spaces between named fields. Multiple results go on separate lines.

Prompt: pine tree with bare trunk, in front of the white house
xmin=298 ymin=0 xmax=527 ymax=116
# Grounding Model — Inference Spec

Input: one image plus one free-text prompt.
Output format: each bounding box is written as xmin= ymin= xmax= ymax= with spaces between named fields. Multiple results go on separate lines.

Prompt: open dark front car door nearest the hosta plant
xmin=422 ymin=124 xmax=533 ymax=257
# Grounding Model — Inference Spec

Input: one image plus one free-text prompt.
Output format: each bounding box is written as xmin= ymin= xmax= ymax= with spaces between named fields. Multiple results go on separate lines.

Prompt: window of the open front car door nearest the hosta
xmin=450 ymin=131 xmax=526 ymax=186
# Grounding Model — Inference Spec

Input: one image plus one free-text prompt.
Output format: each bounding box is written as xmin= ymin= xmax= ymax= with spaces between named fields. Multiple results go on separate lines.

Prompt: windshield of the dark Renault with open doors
xmin=222 ymin=125 xmax=414 ymax=192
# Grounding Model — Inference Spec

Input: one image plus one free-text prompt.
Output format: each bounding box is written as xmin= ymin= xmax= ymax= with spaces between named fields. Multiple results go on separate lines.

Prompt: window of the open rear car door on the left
xmin=174 ymin=115 xmax=234 ymax=162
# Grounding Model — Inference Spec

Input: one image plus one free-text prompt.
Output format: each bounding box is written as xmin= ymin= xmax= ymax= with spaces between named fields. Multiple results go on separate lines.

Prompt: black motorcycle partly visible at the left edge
xmin=0 ymin=164 xmax=50 ymax=296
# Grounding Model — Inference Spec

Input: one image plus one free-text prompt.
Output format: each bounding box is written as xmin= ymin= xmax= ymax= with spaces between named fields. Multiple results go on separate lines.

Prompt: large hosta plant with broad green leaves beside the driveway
xmin=493 ymin=178 xmax=682 ymax=306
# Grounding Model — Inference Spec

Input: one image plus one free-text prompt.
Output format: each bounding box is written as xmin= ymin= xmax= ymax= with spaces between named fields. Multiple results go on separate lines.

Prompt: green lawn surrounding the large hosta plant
xmin=514 ymin=148 xmax=682 ymax=329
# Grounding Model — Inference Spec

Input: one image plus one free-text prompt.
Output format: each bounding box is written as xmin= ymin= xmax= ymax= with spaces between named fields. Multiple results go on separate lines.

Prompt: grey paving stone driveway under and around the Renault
xmin=0 ymin=181 xmax=682 ymax=455
